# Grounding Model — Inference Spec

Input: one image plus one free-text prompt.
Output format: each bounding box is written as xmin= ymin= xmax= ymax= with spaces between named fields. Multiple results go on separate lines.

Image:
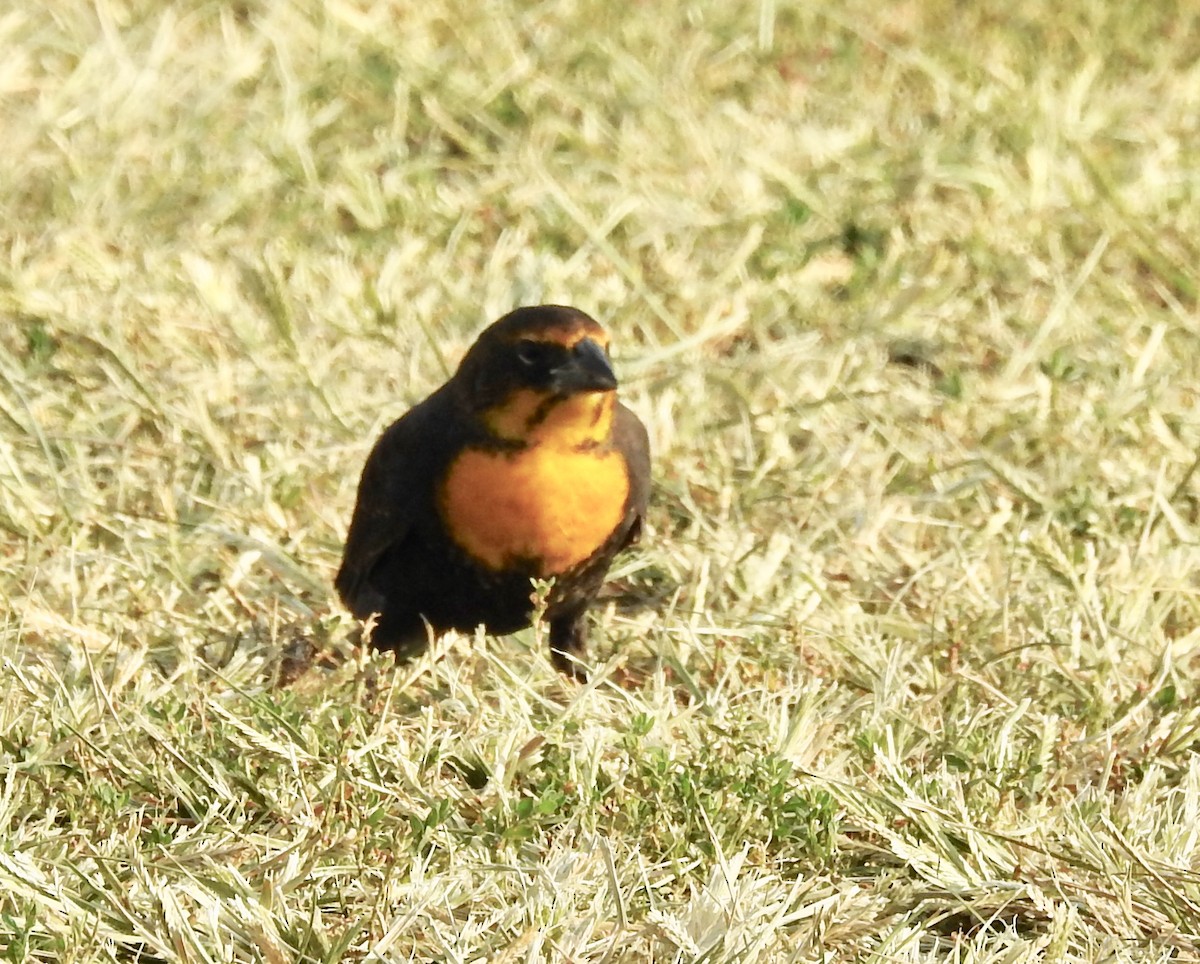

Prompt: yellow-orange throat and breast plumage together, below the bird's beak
xmin=439 ymin=389 xmax=629 ymax=579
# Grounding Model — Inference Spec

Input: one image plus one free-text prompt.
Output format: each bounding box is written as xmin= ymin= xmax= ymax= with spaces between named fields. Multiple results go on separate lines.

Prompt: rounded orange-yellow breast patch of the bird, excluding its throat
xmin=439 ymin=445 xmax=629 ymax=579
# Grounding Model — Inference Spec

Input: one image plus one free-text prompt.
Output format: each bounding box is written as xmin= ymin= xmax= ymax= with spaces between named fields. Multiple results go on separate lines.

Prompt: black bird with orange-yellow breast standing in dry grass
xmin=336 ymin=305 xmax=650 ymax=677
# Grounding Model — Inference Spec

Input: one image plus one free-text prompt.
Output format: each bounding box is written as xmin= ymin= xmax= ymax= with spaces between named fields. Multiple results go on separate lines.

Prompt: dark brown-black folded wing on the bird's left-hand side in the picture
xmin=334 ymin=387 xmax=455 ymax=618
